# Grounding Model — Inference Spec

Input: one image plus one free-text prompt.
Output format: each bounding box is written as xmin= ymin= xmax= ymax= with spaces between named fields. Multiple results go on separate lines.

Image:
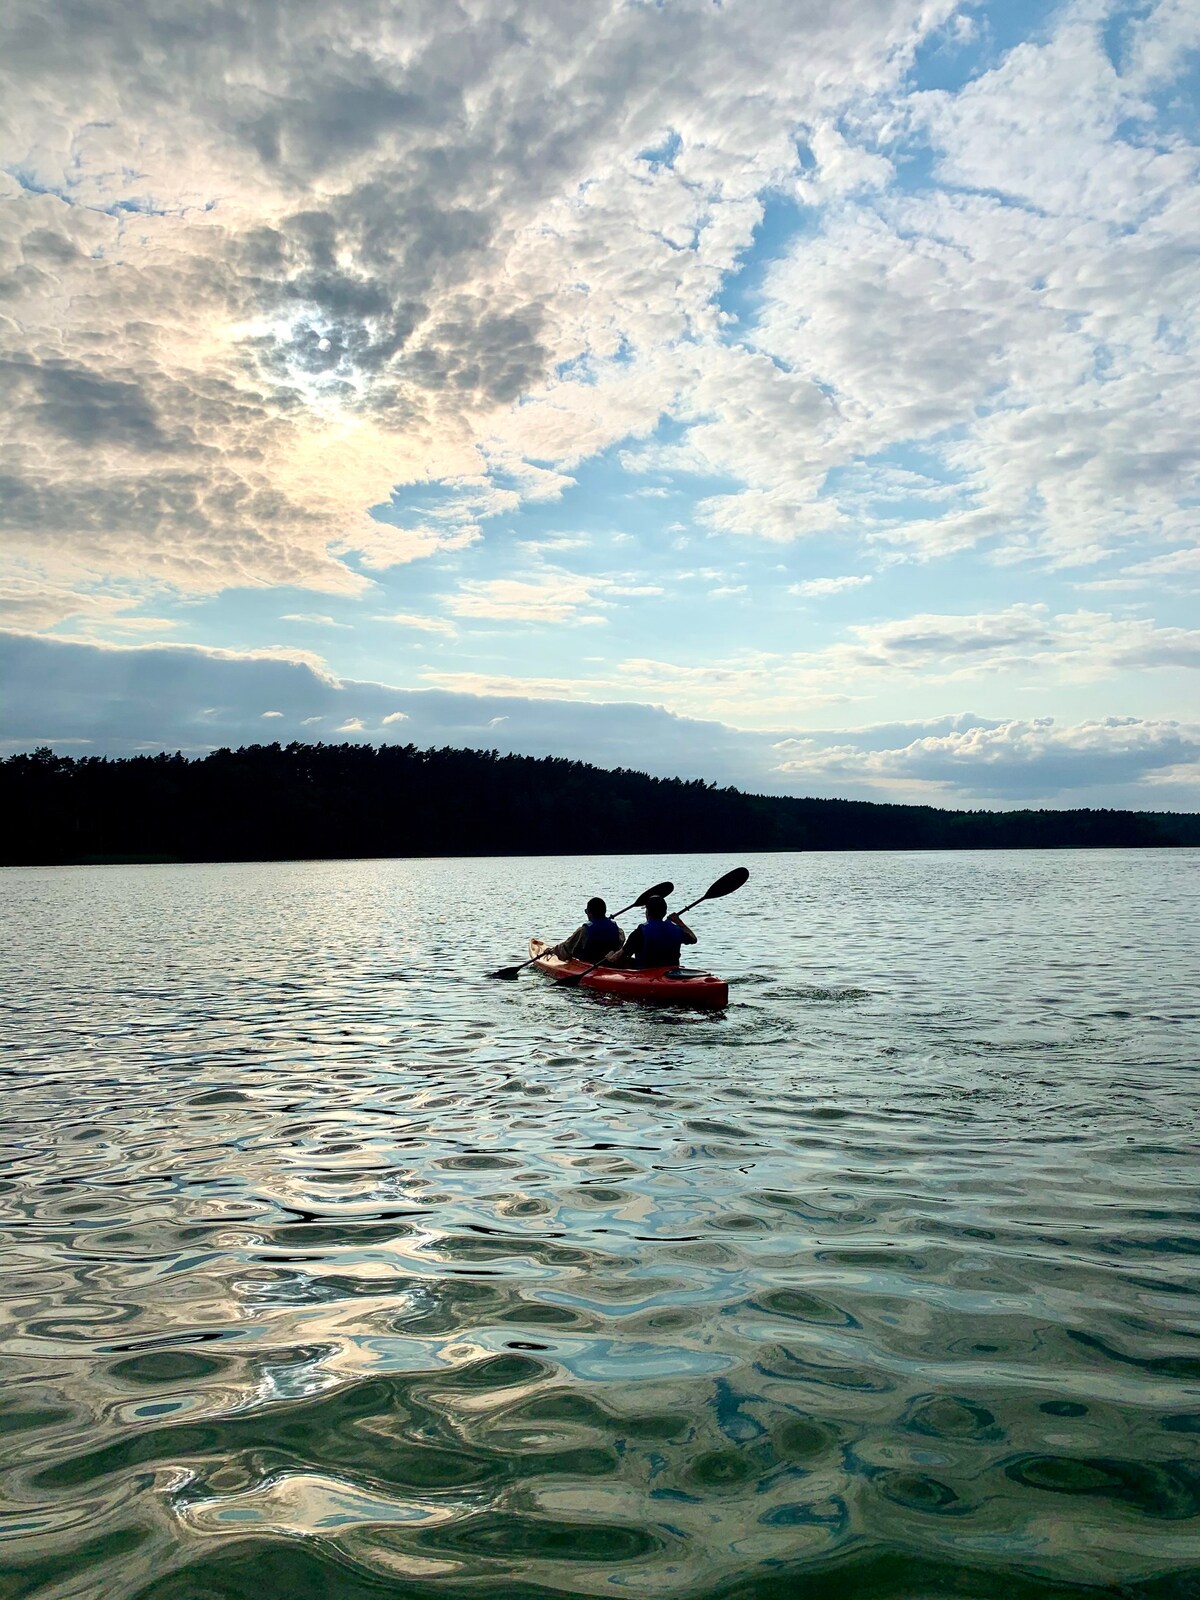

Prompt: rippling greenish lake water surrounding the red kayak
xmin=0 ymin=851 xmax=1200 ymax=1600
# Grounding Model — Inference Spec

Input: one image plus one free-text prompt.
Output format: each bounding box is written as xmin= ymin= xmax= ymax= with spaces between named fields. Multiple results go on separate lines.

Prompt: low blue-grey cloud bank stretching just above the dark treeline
xmin=0 ymin=634 xmax=1200 ymax=810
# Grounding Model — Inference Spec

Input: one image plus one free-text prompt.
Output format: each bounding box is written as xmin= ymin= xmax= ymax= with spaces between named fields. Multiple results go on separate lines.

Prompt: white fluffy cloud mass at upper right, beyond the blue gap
xmin=668 ymin=5 xmax=1200 ymax=562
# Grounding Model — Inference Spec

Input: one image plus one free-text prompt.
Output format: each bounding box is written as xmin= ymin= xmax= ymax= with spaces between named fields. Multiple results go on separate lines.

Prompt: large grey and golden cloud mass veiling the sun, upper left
xmin=0 ymin=0 xmax=972 ymax=611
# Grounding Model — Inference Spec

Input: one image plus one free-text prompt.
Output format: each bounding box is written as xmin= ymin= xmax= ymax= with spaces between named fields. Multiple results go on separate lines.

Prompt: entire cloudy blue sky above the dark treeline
xmin=0 ymin=0 xmax=1200 ymax=811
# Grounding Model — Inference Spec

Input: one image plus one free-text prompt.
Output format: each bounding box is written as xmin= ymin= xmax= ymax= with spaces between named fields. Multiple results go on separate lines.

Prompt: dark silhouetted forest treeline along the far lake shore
xmin=0 ymin=744 xmax=1200 ymax=864
